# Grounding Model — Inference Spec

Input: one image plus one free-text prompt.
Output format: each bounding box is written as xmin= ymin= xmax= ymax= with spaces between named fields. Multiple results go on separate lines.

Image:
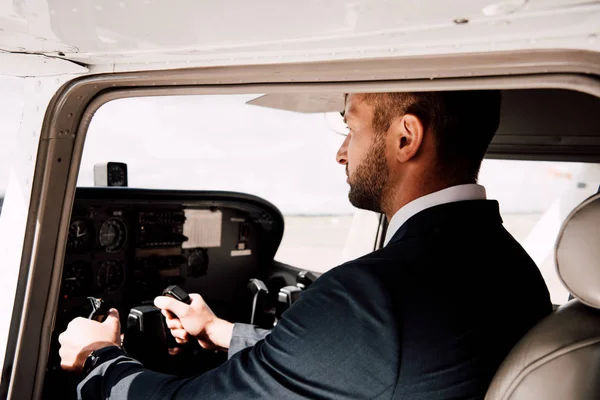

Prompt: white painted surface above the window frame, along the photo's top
xmin=0 ymin=0 xmax=600 ymax=70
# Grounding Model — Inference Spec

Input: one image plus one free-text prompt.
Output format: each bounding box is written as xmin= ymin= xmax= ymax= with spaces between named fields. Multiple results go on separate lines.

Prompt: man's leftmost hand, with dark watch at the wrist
xmin=58 ymin=309 xmax=121 ymax=372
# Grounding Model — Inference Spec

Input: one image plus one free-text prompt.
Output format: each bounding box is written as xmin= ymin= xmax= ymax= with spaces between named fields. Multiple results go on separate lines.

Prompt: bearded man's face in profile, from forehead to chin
xmin=336 ymin=94 xmax=389 ymax=213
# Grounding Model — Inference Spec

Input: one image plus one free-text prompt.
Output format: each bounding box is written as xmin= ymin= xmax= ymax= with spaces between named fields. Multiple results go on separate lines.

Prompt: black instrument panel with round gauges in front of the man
xmin=44 ymin=188 xmax=283 ymax=398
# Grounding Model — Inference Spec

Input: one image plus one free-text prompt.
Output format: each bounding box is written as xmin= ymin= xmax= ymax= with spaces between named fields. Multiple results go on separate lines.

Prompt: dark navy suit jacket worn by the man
xmin=78 ymin=200 xmax=551 ymax=400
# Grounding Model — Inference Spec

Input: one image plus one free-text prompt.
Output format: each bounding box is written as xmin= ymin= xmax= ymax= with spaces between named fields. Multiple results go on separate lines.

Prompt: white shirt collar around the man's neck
xmin=383 ymin=183 xmax=487 ymax=246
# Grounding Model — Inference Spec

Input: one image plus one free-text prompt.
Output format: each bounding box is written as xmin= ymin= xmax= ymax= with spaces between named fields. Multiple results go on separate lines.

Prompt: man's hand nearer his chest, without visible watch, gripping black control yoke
xmin=154 ymin=293 xmax=233 ymax=351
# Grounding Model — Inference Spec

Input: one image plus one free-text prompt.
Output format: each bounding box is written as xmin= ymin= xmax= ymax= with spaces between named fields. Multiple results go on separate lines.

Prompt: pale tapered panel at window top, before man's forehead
xmin=246 ymin=93 xmax=344 ymax=113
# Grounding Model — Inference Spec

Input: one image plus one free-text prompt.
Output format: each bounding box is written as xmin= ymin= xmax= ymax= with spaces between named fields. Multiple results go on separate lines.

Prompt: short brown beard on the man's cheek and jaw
xmin=346 ymin=138 xmax=390 ymax=213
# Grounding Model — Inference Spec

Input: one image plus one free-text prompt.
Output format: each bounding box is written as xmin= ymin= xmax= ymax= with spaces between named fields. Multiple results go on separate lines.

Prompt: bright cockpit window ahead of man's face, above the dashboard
xmin=78 ymin=94 xmax=370 ymax=272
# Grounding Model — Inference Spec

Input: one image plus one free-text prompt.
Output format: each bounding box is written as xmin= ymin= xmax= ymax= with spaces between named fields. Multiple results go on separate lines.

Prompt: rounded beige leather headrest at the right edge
xmin=555 ymin=194 xmax=600 ymax=308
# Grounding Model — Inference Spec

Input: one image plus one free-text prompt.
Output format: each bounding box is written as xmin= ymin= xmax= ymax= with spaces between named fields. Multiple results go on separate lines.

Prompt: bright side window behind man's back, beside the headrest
xmin=479 ymin=159 xmax=600 ymax=304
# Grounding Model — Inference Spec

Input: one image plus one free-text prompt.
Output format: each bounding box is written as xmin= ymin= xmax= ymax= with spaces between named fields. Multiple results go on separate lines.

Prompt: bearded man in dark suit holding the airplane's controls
xmin=60 ymin=91 xmax=551 ymax=400
